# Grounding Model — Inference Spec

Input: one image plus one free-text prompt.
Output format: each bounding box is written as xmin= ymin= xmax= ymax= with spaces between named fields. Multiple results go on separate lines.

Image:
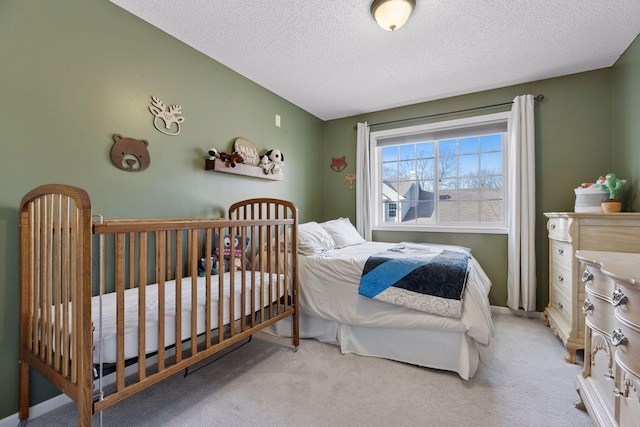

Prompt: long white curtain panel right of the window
xmin=507 ymin=95 xmax=536 ymax=311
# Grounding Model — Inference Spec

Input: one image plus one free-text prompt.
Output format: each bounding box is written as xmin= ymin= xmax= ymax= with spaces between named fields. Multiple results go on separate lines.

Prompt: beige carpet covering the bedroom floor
xmin=22 ymin=314 xmax=591 ymax=427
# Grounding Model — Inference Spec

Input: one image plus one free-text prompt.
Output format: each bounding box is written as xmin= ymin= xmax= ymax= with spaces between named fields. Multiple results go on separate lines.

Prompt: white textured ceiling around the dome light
xmin=111 ymin=0 xmax=640 ymax=120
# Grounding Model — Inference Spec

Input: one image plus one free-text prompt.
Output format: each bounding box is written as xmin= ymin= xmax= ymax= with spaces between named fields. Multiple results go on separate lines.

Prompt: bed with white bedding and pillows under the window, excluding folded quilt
xmin=269 ymin=218 xmax=494 ymax=380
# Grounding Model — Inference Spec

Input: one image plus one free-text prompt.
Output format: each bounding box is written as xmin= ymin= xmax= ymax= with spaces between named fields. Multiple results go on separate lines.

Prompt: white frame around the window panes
xmin=369 ymin=112 xmax=510 ymax=234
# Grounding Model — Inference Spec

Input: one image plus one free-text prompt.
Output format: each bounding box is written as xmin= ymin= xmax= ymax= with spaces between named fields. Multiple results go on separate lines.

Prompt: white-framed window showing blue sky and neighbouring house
xmin=370 ymin=113 xmax=509 ymax=233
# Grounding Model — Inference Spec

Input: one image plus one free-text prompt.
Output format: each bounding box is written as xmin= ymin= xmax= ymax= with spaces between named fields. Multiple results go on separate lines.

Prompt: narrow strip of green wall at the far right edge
xmin=612 ymin=37 xmax=640 ymax=212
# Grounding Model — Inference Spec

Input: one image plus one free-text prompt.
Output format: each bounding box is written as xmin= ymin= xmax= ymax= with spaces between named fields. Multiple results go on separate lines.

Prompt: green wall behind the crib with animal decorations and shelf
xmin=0 ymin=0 xmax=323 ymax=419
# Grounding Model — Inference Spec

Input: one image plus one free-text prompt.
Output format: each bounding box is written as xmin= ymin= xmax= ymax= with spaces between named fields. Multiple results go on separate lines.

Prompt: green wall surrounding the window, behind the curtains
xmin=323 ymin=69 xmax=612 ymax=311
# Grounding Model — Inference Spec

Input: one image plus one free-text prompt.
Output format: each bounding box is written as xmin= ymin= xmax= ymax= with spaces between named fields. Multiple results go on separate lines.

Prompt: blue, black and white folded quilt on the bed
xmin=358 ymin=243 xmax=471 ymax=318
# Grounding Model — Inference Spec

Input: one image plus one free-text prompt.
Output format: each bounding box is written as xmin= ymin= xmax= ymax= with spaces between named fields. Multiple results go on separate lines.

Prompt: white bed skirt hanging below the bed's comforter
xmin=265 ymin=313 xmax=484 ymax=380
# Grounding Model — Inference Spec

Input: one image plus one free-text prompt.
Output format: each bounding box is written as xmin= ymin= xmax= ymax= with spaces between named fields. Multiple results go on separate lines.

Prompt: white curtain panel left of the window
xmin=356 ymin=122 xmax=372 ymax=240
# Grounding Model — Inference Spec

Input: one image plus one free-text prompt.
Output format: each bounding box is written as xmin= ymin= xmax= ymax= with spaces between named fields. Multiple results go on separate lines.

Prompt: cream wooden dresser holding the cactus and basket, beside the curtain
xmin=544 ymin=212 xmax=640 ymax=363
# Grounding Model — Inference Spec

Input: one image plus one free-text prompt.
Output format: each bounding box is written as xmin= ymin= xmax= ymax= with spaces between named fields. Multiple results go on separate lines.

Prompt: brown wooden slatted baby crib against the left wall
xmin=19 ymin=184 xmax=299 ymax=426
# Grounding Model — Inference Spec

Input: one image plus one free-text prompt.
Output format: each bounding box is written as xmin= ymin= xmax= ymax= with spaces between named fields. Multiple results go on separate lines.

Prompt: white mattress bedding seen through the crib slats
xmin=91 ymin=271 xmax=284 ymax=363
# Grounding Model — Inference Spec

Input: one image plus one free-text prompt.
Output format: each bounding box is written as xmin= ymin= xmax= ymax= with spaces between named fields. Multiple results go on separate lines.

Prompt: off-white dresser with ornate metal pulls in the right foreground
xmin=576 ymin=251 xmax=640 ymax=427
